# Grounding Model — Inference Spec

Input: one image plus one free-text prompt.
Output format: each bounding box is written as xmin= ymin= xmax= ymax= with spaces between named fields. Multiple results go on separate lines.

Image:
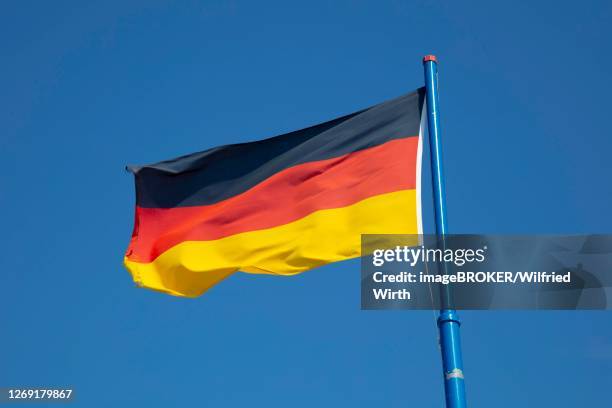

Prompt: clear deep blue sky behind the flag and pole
xmin=0 ymin=0 xmax=612 ymax=407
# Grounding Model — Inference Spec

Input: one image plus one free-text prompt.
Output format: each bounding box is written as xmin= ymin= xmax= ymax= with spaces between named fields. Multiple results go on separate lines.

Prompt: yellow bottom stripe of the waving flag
xmin=124 ymin=190 xmax=418 ymax=297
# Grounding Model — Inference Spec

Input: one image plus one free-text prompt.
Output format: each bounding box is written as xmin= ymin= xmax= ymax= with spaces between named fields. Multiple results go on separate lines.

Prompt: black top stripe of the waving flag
xmin=128 ymin=88 xmax=425 ymax=208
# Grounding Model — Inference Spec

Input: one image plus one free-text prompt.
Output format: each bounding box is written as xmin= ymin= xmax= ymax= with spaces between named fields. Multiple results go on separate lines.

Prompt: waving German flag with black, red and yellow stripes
xmin=124 ymin=88 xmax=425 ymax=297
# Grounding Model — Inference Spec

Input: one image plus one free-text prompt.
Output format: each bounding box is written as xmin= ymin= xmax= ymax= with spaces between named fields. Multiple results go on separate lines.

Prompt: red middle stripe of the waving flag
xmin=127 ymin=137 xmax=418 ymax=262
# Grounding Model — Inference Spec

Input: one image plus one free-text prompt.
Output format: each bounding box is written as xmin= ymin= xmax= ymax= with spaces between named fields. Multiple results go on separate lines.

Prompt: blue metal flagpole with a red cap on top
xmin=423 ymin=55 xmax=466 ymax=408
